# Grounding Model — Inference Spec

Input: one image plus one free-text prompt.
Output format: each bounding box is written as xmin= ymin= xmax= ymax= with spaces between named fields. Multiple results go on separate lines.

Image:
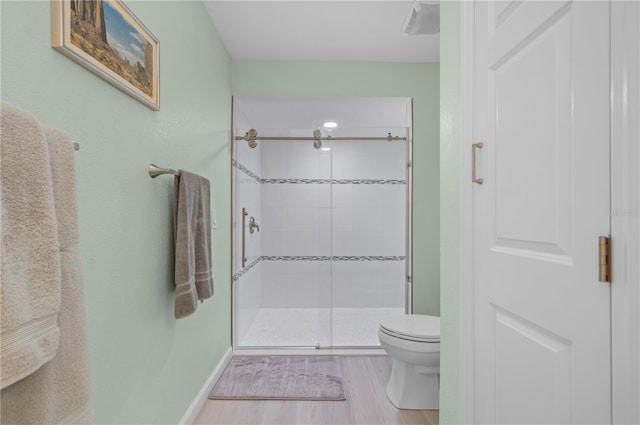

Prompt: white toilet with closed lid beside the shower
xmin=378 ymin=314 xmax=440 ymax=409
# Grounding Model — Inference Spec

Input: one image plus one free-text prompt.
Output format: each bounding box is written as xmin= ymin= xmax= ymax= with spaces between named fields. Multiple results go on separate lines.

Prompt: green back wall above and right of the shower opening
xmin=232 ymin=61 xmax=440 ymax=315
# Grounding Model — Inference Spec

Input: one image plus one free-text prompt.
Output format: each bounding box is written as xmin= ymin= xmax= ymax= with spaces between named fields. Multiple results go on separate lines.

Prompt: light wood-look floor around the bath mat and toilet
xmin=194 ymin=356 xmax=438 ymax=425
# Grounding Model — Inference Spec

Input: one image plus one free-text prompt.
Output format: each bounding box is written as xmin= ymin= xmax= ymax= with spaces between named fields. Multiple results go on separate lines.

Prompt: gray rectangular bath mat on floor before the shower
xmin=209 ymin=356 xmax=346 ymax=400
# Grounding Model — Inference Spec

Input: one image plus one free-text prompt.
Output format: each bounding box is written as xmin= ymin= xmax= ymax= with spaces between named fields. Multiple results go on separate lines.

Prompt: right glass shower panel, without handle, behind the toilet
xmin=331 ymin=134 xmax=407 ymax=347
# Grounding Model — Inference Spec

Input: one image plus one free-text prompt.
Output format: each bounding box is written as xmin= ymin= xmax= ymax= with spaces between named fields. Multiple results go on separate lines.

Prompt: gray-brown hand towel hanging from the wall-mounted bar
xmin=174 ymin=170 xmax=213 ymax=319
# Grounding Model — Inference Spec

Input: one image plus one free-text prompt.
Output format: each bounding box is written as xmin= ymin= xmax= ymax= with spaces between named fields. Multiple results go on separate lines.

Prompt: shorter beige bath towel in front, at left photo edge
xmin=0 ymin=102 xmax=60 ymax=388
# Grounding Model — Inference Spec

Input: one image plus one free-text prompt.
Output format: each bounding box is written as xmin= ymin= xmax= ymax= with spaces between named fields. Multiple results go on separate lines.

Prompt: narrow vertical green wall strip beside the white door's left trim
xmin=440 ymin=1 xmax=460 ymax=424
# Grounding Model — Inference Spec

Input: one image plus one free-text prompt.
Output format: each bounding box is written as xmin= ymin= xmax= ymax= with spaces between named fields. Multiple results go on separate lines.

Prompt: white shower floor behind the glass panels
xmin=236 ymin=307 xmax=404 ymax=348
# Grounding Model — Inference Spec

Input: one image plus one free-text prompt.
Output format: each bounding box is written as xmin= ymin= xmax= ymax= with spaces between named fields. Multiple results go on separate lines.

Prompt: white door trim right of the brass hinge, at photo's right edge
xmin=610 ymin=1 xmax=640 ymax=424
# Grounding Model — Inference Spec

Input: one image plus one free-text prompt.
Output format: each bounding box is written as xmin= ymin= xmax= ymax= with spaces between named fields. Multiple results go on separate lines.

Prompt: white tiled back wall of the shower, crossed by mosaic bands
xmin=260 ymin=141 xmax=406 ymax=308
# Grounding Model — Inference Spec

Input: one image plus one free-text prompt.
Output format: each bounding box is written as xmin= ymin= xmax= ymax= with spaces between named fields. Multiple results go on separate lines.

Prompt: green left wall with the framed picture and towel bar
xmin=1 ymin=1 xmax=231 ymax=424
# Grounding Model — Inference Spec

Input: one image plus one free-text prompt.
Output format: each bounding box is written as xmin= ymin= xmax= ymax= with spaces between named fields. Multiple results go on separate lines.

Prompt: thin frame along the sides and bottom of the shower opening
xmin=229 ymin=96 xmax=413 ymax=351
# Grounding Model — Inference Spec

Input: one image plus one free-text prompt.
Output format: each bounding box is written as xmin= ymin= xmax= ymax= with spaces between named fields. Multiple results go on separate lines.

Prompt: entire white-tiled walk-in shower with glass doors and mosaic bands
xmin=232 ymin=97 xmax=411 ymax=348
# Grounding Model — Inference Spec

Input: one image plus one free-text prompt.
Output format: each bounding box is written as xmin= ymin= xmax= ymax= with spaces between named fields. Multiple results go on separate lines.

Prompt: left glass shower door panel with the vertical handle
xmin=233 ymin=129 xmax=332 ymax=348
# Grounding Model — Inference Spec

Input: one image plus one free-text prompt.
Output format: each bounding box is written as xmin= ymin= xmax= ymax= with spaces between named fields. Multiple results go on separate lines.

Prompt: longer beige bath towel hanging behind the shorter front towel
xmin=0 ymin=121 xmax=93 ymax=425
